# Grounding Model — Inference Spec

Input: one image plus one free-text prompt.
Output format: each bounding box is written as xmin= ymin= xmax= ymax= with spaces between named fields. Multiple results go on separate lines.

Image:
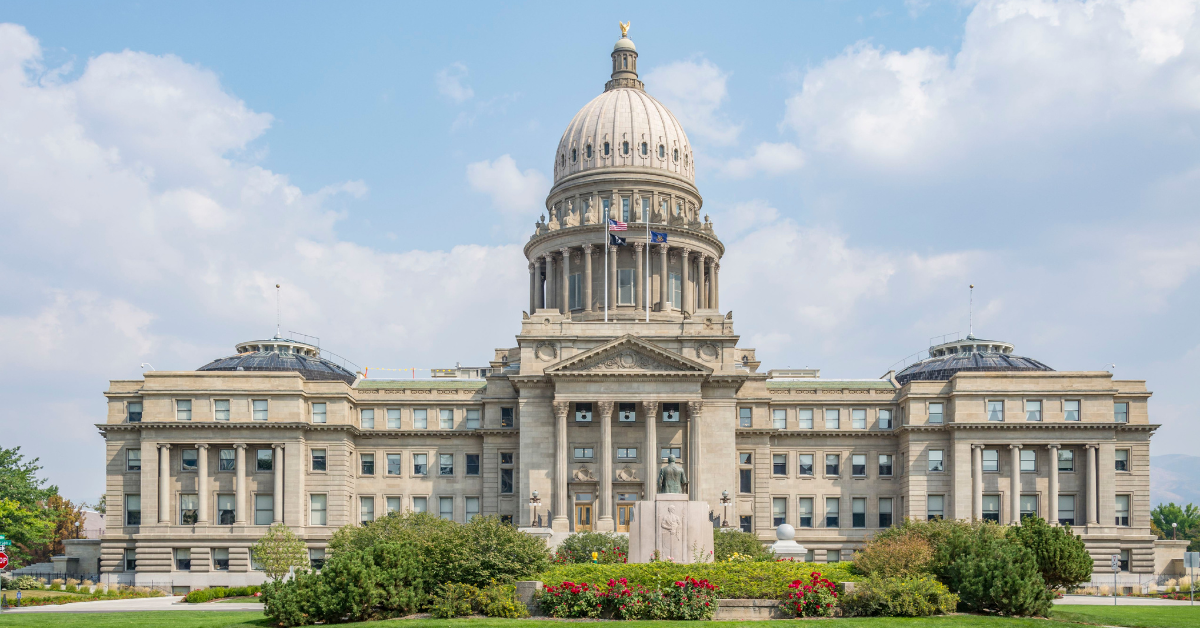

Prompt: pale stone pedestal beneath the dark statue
xmin=628 ymin=494 xmax=713 ymax=563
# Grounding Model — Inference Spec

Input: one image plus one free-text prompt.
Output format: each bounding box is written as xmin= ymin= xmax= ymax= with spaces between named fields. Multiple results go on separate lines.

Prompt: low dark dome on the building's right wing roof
xmin=896 ymin=335 xmax=1054 ymax=385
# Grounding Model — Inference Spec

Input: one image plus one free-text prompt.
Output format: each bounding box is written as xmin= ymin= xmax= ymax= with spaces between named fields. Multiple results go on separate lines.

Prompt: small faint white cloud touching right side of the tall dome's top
xmin=646 ymin=59 xmax=742 ymax=145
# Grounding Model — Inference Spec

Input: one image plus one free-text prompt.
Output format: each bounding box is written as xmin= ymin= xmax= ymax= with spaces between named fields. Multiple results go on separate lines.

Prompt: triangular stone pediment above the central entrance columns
xmin=545 ymin=335 xmax=713 ymax=376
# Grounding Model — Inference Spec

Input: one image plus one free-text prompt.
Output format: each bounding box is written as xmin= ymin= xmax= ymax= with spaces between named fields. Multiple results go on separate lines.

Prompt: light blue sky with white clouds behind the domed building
xmin=0 ymin=0 xmax=1200 ymax=502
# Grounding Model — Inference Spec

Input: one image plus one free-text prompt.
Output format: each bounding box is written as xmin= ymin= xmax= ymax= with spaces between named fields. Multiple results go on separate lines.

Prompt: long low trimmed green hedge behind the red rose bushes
xmin=538 ymin=561 xmax=862 ymax=599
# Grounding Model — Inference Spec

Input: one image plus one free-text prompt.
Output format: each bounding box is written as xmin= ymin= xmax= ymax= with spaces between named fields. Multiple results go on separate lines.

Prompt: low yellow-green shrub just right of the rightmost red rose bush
xmin=841 ymin=575 xmax=959 ymax=617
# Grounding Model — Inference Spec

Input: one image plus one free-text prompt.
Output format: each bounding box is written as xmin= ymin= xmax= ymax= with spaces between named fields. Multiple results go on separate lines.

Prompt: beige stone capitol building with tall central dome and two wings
xmin=97 ymin=28 xmax=1163 ymax=587
